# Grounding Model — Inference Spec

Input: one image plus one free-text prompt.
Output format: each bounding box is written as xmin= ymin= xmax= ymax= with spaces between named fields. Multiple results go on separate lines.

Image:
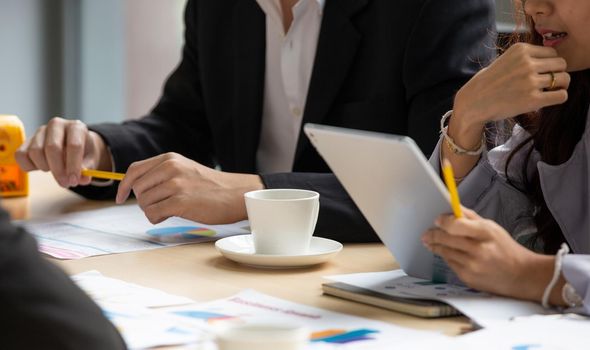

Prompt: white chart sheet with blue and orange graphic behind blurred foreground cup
xmin=168 ymin=290 xmax=446 ymax=350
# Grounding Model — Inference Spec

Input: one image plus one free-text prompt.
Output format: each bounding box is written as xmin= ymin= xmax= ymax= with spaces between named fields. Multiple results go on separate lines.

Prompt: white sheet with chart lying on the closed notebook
xmin=326 ymin=270 xmax=548 ymax=327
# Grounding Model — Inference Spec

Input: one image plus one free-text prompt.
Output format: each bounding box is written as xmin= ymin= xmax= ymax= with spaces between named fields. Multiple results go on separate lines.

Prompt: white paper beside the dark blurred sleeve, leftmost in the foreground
xmin=71 ymin=271 xmax=195 ymax=307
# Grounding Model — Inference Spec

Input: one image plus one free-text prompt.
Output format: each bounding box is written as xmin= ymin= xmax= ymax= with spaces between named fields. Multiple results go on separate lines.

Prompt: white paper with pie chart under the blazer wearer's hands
xmin=21 ymin=205 xmax=249 ymax=259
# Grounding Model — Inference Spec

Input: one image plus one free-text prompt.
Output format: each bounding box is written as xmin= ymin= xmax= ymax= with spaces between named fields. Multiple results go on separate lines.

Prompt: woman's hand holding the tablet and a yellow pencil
xmin=422 ymin=208 xmax=553 ymax=301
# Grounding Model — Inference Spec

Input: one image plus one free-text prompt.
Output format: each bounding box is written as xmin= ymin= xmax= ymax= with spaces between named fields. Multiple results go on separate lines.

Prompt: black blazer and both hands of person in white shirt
xmin=17 ymin=0 xmax=495 ymax=242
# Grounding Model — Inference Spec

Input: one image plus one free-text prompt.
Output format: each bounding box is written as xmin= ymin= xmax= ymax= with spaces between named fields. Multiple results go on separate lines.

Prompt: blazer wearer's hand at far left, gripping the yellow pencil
xmin=15 ymin=117 xmax=112 ymax=187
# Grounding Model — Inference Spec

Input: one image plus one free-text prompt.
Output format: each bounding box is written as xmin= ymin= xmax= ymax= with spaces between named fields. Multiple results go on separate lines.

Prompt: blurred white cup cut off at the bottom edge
xmin=215 ymin=322 xmax=309 ymax=350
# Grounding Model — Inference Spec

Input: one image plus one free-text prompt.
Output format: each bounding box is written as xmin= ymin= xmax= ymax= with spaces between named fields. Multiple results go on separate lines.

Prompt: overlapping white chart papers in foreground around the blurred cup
xmin=73 ymin=271 xmax=445 ymax=349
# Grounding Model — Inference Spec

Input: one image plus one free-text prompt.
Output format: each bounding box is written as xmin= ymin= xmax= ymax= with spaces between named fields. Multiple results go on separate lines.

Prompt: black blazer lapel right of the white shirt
xmin=295 ymin=0 xmax=369 ymax=162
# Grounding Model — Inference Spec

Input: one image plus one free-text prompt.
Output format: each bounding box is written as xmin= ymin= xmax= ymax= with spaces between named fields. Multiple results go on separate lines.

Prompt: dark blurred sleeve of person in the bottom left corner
xmin=0 ymin=209 xmax=126 ymax=350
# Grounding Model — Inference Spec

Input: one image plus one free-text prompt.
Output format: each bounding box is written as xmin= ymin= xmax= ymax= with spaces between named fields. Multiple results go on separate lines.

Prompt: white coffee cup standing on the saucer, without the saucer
xmin=244 ymin=189 xmax=320 ymax=255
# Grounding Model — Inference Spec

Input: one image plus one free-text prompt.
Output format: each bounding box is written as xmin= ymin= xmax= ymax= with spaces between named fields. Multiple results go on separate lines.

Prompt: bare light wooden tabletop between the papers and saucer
xmin=2 ymin=172 xmax=469 ymax=335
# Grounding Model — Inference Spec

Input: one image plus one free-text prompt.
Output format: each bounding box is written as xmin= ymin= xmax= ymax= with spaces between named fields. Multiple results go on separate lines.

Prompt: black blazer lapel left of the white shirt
xmin=230 ymin=0 xmax=266 ymax=172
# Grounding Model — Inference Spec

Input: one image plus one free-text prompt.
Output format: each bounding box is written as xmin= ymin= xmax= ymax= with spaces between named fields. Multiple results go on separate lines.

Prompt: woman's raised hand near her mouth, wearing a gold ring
xmin=450 ymin=43 xmax=570 ymax=135
